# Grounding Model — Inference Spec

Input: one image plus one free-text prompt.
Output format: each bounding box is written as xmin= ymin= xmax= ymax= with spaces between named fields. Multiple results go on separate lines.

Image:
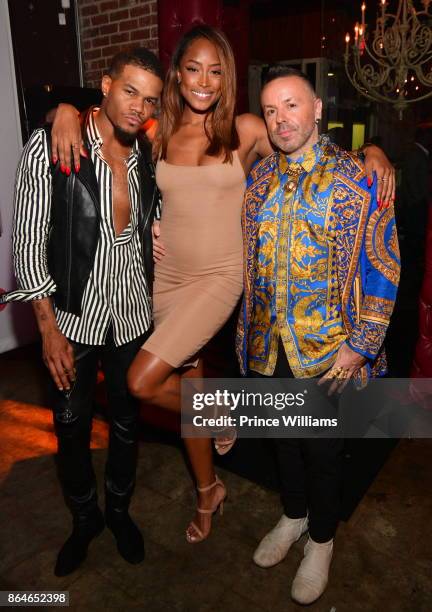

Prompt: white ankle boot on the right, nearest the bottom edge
xmin=291 ymin=537 xmax=333 ymax=604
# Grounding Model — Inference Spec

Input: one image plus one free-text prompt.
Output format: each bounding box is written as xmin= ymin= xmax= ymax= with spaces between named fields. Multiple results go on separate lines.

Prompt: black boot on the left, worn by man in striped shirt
xmin=54 ymin=507 xmax=105 ymax=577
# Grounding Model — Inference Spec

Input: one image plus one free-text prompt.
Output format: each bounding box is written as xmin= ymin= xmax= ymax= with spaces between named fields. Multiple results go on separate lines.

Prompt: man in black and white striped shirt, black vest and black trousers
xmin=4 ymin=49 xmax=163 ymax=576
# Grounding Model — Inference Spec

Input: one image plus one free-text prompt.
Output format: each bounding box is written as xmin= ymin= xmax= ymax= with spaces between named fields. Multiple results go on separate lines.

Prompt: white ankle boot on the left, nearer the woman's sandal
xmin=253 ymin=514 xmax=308 ymax=567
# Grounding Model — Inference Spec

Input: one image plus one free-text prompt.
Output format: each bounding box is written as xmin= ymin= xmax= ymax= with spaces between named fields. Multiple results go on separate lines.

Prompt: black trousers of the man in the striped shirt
xmin=52 ymin=328 xmax=144 ymax=515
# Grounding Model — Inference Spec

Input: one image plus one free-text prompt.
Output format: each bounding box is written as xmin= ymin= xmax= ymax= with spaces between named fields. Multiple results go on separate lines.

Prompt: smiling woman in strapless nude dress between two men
xmin=53 ymin=25 xmax=392 ymax=543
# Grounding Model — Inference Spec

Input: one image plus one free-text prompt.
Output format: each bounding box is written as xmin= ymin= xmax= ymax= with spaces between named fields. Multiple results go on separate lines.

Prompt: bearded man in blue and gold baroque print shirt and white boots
xmin=237 ymin=66 xmax=399 ymax=604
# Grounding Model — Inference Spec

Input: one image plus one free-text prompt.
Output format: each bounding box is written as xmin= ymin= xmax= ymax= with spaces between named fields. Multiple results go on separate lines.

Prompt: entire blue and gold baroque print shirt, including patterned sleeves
xmin=240 ymin=136 xmax=400 ymax=386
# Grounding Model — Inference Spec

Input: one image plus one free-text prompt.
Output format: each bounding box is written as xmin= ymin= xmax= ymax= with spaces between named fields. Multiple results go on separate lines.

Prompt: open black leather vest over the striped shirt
xmin=47 ymin=109 xmax=159 ymax=316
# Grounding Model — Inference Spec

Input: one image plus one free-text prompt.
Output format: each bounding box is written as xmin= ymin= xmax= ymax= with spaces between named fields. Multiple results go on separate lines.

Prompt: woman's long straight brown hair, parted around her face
xmin=159 ymin=24 xmax=239 ymax=163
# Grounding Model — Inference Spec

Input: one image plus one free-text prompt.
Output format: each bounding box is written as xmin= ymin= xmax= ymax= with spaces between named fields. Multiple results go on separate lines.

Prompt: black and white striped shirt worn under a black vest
xmin=6 ymin=110 xmax=151 ymax=346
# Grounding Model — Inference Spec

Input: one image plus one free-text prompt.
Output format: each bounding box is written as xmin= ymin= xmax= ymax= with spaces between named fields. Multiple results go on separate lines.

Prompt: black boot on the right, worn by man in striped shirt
xmin=105 ymin=508 xmax=145 ymax=565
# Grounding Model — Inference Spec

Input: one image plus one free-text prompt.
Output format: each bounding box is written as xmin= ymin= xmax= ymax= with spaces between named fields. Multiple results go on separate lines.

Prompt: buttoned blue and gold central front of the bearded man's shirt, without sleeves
xmin=248 ymin=138 xmax=347 ymax=376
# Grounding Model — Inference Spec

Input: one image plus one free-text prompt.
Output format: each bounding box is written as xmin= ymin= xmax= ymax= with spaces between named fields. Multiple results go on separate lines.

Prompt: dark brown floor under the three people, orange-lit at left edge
xmin=0 ymin=347 xmax=432 ymax=612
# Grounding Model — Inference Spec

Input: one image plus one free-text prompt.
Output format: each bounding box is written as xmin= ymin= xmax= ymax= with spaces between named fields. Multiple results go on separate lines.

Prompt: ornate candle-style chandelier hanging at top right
xmin=344 ymin=0 xmax=432 ymax=118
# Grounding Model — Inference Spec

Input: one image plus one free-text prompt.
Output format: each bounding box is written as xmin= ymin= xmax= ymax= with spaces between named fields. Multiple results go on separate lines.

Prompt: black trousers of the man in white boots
xmin=251 ymin=343 xmax=343 ymax=542
